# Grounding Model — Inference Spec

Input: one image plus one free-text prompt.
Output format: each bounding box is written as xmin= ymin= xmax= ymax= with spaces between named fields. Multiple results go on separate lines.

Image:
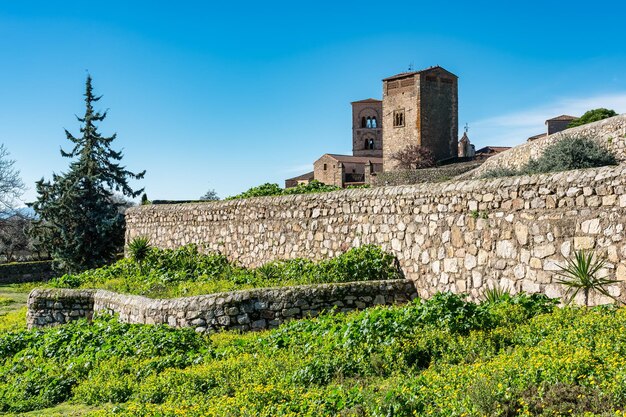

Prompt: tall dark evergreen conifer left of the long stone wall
xmin=31 ymin=76 xmax=145 ymax=272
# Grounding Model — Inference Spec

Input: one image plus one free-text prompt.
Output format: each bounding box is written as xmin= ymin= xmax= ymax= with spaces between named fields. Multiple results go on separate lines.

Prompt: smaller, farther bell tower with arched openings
xmin=351 ymin=98 xmax=383 ymax=157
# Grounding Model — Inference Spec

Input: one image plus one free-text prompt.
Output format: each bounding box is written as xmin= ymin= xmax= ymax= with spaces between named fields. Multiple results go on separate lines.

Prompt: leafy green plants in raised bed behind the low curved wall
xmin=48 ymin=244 xmax=400 ymax=297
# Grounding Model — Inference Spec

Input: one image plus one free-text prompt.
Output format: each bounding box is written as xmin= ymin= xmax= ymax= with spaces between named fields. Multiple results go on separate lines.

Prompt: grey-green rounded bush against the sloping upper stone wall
xmin=482 ymin=138 xmax=617 ymax=178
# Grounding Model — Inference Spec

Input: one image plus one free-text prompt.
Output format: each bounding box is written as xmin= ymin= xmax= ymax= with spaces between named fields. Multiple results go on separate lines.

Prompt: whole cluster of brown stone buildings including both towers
xmin=285 ymin=66 xmax=460 ymax=187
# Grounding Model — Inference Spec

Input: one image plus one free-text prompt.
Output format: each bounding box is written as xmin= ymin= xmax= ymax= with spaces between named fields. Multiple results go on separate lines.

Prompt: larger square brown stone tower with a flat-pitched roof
xmin=383 ymin=66 xmax=458 ymax=171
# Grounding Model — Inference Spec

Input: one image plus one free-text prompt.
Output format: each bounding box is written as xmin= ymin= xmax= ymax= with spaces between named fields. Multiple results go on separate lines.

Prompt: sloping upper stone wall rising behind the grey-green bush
xmin=466 ymin=114 xmax=626 ymax=179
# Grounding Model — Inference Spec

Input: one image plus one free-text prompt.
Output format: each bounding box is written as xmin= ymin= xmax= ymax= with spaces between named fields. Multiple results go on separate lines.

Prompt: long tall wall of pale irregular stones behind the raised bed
xmin=126 ymin=165 xmax=626 ymax=303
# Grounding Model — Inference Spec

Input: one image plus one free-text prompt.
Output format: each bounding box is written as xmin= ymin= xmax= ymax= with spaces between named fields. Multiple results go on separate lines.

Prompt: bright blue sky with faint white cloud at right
xmin=0 ymin=0 xmax=626 ymax=201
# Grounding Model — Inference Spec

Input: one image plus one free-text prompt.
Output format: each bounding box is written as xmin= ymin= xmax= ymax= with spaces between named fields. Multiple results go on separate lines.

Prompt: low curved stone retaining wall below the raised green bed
xmin=27 ymin=280 xmax=417 ymax=332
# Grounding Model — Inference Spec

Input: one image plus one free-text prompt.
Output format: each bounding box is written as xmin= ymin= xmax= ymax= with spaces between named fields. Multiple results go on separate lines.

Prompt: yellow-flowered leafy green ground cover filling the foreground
xmin=0 ymin=294 xmax=626 ymax=417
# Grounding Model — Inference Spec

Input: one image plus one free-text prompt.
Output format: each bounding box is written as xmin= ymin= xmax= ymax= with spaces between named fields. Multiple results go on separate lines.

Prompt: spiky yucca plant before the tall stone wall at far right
xmin=557 ymin=250 xmax=619 ymax=306
